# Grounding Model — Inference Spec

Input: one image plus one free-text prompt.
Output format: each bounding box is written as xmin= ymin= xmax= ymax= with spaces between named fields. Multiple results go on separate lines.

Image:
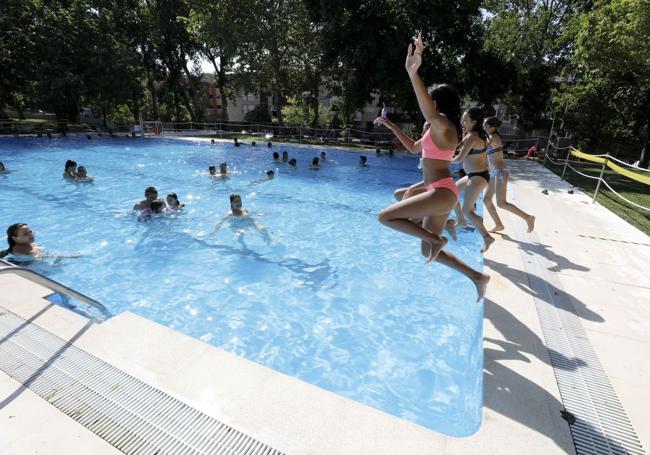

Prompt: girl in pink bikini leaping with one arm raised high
xmin=372 ymin=33 xmax=490 ymax=299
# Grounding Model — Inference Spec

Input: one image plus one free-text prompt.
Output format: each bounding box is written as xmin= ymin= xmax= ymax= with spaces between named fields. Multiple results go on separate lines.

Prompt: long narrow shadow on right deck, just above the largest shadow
xmin=483 ymin=258 xmax=605 ymax=322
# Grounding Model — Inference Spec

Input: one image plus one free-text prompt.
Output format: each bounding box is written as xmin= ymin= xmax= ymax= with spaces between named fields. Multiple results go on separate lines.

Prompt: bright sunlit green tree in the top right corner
xmin=558 ymin=0 xmax=650 ymax=167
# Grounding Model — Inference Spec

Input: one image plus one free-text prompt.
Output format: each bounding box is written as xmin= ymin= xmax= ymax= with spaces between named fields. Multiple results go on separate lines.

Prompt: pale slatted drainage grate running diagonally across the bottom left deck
xmin=0 ymin=307 xmax=281 ymax=455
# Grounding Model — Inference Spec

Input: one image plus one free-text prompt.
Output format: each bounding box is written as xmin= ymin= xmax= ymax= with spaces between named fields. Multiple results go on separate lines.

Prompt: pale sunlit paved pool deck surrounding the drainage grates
xmin=0 ymin=154 xmax=650 ymax=455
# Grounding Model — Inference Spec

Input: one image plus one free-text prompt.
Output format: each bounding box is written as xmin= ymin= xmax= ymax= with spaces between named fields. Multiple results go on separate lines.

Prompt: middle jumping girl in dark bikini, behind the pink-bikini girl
xmin=452 ymin=107 xmax=494 ymax=253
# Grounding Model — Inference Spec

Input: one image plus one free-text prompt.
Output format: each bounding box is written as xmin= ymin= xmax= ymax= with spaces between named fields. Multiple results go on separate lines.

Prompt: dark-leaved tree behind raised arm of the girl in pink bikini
xmin=306 ymin=0 xmax=503 ymax=123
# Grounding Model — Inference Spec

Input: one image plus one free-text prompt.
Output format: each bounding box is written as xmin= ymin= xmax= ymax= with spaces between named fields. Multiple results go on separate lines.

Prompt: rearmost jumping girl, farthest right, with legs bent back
xmin=483 ymin=117 xmax=535 ymax=232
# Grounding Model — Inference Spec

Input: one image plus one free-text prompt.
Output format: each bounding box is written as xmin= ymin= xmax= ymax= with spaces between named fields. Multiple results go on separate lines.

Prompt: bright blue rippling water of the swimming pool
xmin=0 ymin=138 xmax=483 ymax=436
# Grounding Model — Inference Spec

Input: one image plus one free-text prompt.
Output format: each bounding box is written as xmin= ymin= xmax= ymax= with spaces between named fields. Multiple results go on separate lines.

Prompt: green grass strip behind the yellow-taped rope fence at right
xmin=546 ymin=162 xmax=650 ymax=235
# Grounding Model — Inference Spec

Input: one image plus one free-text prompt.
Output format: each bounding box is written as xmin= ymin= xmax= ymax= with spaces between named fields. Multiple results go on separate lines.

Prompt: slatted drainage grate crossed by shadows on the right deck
xmin=512 ymin=208 xmax=645 ymax=455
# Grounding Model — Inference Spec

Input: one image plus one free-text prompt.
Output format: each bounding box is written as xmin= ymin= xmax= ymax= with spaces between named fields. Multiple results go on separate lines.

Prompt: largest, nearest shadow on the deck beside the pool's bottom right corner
xmin=483 ymin=299 xmax=626 ymax=454
